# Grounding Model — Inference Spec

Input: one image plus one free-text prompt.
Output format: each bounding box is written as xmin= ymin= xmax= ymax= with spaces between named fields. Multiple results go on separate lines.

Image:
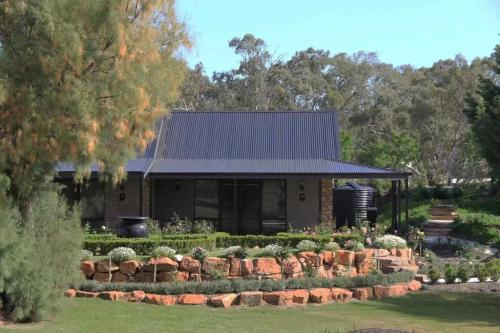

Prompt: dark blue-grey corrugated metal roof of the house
xmin=58 ymin=111 xmax=409 ymax=179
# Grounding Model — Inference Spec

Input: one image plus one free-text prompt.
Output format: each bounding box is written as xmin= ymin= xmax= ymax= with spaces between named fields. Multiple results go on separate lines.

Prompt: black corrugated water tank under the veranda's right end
xmin=333 ymin=182 xmax=375 ymax=227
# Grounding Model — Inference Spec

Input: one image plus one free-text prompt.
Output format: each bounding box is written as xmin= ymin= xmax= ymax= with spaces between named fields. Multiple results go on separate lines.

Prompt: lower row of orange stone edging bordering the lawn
xmin=66 ymin=280 xmax=422 ymax=308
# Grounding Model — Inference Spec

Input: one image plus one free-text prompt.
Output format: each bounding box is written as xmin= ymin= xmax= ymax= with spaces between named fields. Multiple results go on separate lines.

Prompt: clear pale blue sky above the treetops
xmin=177 ymin=0 xmax=500 ymax=75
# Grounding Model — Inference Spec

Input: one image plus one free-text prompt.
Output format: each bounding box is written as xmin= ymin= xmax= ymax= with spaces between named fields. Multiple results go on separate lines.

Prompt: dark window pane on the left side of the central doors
xmin=194 ymin=180 xmax=219 ymax=226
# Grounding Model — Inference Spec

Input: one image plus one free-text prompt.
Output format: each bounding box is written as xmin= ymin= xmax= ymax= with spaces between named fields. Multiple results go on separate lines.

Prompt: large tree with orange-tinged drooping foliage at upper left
xmin=0 ymin=0 xmax=190 ymax=208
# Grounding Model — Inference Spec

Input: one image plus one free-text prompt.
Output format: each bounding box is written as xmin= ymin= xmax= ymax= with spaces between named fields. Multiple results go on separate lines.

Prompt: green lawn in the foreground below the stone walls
xmin=0 ymin=292 xmax=500 ymax=333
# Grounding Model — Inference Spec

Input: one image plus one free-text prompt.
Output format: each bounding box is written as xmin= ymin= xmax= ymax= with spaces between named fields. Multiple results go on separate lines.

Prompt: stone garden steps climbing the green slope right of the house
xmin=422 ymin=205 xmax=457 ymax=237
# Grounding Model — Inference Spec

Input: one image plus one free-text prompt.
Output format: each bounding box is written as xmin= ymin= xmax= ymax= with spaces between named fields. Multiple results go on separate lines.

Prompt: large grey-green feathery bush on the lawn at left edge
xmin=0 ymin=191 xmax=83 ymax=321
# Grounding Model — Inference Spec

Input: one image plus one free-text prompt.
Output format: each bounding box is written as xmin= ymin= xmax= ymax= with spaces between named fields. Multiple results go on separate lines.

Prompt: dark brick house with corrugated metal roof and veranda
xmin=58 ymin=111 xmax=409 ymax=234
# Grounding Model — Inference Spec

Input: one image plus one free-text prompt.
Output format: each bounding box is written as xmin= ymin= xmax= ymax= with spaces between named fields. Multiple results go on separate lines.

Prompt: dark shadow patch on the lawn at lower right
xmin=360 ymin=292 xmax=500 ymax=327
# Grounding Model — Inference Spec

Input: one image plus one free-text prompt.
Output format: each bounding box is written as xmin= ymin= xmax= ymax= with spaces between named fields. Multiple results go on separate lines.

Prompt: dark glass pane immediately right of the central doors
xmin=262 ymin=180 xmax=286 ymax=234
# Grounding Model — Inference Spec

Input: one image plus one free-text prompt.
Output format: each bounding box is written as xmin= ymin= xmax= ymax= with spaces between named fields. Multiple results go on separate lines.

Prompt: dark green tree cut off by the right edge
xmin=465 ymin=45 xmax=500 ymax=193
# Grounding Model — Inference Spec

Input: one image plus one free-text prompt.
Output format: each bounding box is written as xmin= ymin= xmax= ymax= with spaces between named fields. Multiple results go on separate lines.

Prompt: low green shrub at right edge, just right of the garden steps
xmin=452 ymin=216 xmax=500 ymax=245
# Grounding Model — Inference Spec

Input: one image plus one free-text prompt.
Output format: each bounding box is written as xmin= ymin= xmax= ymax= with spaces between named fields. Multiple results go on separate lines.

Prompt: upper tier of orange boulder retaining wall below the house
xmin=81 ymin=249 xmax=417 ymax=282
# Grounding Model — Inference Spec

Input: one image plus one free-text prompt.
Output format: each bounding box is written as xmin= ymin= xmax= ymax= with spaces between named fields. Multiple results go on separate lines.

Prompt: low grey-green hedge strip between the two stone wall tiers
xmin=76 ymin=271 xmax=414 ymax=295
